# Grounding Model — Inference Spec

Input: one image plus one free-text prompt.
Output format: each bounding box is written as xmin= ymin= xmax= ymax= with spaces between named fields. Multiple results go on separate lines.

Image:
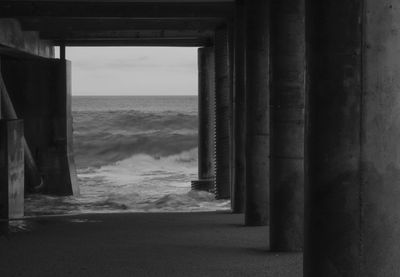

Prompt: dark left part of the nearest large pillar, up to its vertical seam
xmin=304 ymin=0 xmax=362 ymax=277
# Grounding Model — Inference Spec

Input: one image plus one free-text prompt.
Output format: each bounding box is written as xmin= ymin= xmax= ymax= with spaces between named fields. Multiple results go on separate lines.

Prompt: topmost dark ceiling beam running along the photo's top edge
xmin=0 ymin=1 xmax=234 ymax=19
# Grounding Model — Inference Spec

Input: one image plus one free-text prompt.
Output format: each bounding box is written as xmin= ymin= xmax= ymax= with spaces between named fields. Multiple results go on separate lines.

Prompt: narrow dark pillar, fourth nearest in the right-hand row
xmin=231 ymin=1 xmax=246 ymax=213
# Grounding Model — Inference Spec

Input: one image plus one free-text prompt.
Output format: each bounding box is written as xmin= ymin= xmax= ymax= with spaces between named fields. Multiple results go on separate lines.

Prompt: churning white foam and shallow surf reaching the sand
xmin=27 ymin=149 xmax=230 ymax=214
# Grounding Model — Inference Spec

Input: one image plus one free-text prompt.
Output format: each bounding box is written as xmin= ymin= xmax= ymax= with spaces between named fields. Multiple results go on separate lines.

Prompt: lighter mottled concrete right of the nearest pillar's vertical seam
xmin=360 ymin=0 xmax=400 ymax=272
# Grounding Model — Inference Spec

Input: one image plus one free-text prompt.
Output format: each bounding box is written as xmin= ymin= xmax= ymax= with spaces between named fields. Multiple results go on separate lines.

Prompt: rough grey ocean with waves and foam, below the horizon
xmin=25 ymin=96 xmax=230 ymax=216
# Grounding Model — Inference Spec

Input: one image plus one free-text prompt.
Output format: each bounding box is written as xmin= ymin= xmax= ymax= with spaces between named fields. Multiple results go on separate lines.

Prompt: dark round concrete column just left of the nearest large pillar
xmin=270 ymin=0 xmax=306 ymax=251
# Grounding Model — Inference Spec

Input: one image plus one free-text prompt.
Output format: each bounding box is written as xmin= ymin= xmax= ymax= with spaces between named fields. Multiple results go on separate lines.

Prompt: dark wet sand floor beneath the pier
xmin=0 ymin=213 xmax=302 ymax=277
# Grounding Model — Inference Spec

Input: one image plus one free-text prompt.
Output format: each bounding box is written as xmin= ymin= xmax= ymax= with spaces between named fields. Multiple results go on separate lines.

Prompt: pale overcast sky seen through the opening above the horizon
xmin=66 ymin=47 xmax=198 ymax=95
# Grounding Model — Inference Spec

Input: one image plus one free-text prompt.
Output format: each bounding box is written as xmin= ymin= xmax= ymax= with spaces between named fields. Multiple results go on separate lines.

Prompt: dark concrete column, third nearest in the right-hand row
xmin=245 ymin=0 xmax=270 ymax=225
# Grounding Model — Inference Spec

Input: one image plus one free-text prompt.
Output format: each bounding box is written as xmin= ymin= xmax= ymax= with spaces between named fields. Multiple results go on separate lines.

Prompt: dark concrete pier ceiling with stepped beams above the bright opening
xmin=0 ymin=0 xmax=234 ymax=46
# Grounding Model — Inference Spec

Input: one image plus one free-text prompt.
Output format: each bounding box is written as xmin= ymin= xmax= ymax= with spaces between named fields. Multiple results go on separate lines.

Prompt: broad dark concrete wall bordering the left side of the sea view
xmin=2 ymin=59 xmax=79 ymax=195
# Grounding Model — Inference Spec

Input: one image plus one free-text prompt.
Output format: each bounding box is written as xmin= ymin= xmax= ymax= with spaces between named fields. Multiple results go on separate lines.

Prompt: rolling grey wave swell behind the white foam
xmin=74 ymin=111 xmax=197 ymax=168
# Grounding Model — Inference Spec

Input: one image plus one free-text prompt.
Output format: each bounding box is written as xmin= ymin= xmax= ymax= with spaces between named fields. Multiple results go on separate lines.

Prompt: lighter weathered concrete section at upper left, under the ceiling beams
xmin=0 ymin=18 xmax=54 ymax=58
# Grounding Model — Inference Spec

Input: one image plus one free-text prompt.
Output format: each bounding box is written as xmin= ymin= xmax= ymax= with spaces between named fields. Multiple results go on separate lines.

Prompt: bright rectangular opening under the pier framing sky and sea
xmin=27 ymin=47 xmax=230 ymax=214
